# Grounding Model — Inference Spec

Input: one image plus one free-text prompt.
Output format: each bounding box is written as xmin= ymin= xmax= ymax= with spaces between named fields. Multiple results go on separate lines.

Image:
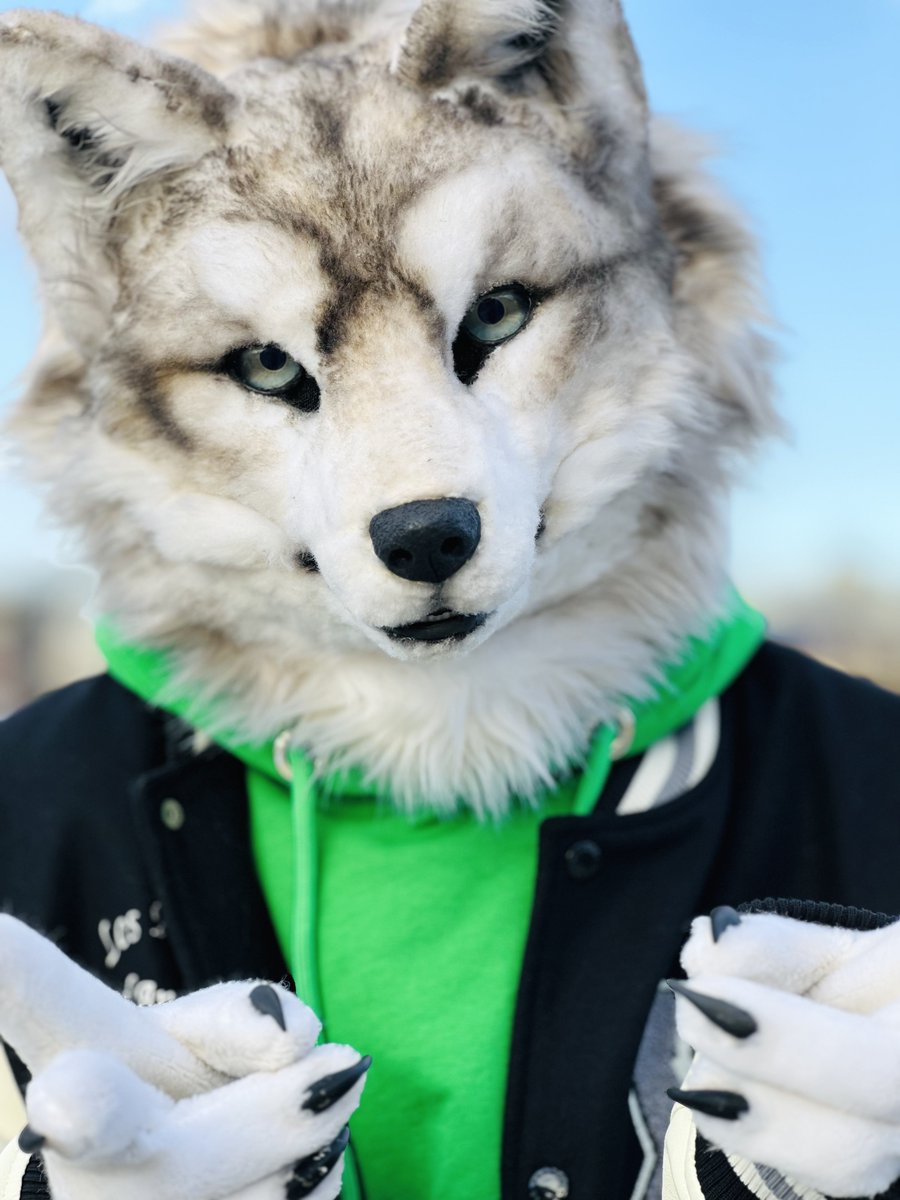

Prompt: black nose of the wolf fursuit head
xmin=368 ymin=499 xmax=481 ymax=583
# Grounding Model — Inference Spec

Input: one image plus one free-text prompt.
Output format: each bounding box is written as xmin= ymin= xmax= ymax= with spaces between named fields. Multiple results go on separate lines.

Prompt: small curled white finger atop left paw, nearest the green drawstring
xmin=148 ymin=980 xmax=322 ymax=1079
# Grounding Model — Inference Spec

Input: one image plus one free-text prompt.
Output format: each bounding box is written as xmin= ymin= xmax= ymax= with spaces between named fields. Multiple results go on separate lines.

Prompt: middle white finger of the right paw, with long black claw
xmin=672 ymin=976 xmax=900 ymax=1122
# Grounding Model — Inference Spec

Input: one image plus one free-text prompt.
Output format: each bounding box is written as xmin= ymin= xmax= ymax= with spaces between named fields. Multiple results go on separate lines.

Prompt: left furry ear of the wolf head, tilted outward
xmin=0 ymin=11 xmax=232 ymax=346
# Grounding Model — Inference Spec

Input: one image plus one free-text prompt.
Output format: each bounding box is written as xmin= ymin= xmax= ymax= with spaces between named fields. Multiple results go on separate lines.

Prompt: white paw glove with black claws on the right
xmin=670 ymin=908 xmax=900 ymax=1196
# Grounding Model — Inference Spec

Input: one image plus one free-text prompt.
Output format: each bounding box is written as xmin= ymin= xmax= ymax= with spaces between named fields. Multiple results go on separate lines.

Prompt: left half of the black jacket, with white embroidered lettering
xmin=0 ymin=676 xmax=287 ymax=1036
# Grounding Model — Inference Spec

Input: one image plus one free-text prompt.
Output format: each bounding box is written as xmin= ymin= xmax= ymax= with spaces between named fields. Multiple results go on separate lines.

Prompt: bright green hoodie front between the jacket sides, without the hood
xmin=251 ymin=774 xmax=577 ymax=1200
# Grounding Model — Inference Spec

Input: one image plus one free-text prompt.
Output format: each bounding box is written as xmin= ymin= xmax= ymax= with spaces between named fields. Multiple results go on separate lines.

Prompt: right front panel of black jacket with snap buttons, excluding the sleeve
xmin=503 ymin=734 xmax=726 ymax=1196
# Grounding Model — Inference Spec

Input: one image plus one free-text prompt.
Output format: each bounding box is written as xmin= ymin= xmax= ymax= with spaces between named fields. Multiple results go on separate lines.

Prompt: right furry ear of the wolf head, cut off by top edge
xmin=395 ymin=0 xmax=647 ymax=169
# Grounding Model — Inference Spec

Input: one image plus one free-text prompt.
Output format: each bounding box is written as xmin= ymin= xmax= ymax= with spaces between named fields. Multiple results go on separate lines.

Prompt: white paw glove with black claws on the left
xmin=0 ymin=914 xmax=370 ymax=1200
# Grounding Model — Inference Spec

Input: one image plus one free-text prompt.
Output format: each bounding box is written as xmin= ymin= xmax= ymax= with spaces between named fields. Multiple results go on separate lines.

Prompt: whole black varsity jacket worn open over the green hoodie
xmin=0 ymin=643 xmax=900 ymax=1200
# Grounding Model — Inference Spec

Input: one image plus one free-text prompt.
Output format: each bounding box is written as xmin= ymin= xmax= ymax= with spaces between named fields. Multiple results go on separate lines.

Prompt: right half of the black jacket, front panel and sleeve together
xmin=502 ymin=643 xmax=900 ymax=1200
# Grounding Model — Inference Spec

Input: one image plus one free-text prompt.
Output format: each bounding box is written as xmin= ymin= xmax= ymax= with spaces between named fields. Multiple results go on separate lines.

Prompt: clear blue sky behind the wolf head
xmin=0 ymin=0 xmax=900 ymax=596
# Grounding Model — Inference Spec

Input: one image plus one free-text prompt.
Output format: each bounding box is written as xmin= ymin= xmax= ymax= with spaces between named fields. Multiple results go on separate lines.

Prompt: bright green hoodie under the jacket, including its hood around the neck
xmin=98 ymin=595 xmax=764 ymax=1200
